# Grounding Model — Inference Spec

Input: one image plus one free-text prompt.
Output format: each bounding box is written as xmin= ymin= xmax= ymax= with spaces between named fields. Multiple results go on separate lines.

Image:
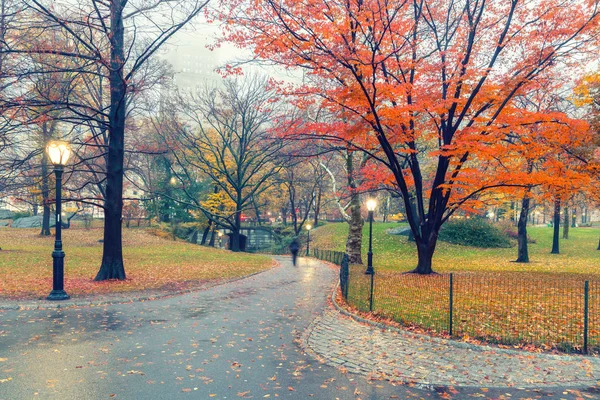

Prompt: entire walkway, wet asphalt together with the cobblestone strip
xmin=0 ymin=257 xmax=600 ymax=400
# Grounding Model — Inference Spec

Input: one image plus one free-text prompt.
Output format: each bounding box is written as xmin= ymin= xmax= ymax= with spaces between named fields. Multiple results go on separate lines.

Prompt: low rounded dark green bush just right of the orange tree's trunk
xmin=439 ymin=218 xmax=513 ymax=248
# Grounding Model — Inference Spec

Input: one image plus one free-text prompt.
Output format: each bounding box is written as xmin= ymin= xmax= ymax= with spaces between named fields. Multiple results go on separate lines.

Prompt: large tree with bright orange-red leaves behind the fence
xmin=215 ymin=0 xmax=600 ymax=274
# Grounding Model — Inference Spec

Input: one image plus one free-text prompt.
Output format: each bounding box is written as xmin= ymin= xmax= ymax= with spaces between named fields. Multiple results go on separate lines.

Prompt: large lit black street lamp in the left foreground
xmin=46 ymin=140 xmax=71 ymax=300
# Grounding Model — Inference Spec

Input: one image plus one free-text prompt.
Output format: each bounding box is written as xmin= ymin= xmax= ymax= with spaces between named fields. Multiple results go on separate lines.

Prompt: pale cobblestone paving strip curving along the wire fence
xmin=303 ymin=292 xmax=600 ymax=388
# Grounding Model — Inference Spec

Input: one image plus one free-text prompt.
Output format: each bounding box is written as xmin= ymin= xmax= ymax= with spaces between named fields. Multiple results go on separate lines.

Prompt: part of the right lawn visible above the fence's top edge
xmin=311 ymin=223 xmax=600 ymax=275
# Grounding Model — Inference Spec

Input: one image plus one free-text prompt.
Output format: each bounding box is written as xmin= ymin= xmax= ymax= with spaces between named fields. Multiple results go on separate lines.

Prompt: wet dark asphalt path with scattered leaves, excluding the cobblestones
xmin=0 ymin=257 xmax=437 ymax=400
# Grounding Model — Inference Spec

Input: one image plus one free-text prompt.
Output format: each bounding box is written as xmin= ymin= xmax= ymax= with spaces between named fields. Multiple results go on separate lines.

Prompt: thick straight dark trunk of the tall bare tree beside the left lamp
xmin=94 ymin=1 xmax=126 ymax=281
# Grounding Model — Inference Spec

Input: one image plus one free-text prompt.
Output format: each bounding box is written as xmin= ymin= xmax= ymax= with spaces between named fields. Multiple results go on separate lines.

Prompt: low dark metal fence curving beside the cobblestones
xmin=322 ymin=250 xmax=600 ymax=353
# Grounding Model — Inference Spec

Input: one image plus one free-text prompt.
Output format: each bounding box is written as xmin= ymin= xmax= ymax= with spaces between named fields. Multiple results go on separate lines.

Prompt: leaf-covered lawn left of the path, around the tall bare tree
xmin=0 ymin=228 xmax=272 ymax=299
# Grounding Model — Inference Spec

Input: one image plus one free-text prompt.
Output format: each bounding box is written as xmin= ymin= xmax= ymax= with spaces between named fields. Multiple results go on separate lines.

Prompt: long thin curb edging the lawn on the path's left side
xmin=0 ymin=259 xmax=281 ymax=311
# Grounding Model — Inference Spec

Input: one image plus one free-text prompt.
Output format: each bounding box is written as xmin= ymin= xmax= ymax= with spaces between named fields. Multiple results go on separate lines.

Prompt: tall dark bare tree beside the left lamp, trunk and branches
xmin=0 ymin=0 xmax=208 ymax=280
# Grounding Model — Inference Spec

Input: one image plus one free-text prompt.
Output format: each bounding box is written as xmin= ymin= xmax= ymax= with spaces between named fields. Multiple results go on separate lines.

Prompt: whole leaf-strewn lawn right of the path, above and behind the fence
xmin=311 ymin=223 xmax=600 ymax=351
